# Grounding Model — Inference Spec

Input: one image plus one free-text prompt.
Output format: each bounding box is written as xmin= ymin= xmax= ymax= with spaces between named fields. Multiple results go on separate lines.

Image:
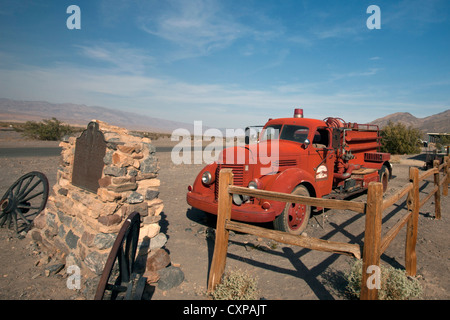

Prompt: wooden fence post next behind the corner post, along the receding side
xmin=405 ymin=168 xmax=420 ymax=276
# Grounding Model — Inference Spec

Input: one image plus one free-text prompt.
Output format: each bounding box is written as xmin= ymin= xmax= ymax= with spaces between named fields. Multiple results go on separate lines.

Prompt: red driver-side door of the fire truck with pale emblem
xmin=308 ymin=127 xmax=336 ymax=196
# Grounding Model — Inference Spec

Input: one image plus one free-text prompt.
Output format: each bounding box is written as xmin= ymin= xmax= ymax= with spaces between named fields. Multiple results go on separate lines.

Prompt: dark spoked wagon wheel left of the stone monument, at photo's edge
xmin=0 ymin=171 xmax=48 ymax=234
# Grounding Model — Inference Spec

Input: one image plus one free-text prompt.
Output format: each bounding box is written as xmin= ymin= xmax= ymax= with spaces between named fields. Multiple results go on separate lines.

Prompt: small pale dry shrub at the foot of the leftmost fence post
xmin=212 ymin=270 xmax=259 ymax=300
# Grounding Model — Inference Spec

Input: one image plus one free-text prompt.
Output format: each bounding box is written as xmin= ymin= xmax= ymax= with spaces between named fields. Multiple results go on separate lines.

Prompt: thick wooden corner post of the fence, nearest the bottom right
xmin=360 ymin=182 xmax=383 ymax=300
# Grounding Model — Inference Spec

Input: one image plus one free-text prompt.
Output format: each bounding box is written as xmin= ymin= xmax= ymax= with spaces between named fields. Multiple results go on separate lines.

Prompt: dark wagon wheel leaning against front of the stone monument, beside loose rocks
xmin=94 ymin=212 xmax=146 ymax=300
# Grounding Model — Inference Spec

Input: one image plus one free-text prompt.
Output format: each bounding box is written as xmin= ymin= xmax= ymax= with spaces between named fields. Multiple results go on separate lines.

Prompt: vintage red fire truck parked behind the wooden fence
xmin=187 ymin=109 xmax=392 ymax=234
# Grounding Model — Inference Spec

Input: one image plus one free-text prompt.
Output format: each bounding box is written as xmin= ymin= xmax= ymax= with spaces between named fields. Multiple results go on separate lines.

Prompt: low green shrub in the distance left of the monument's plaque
xmin=22 ymin=118 xmax=73 ymax=141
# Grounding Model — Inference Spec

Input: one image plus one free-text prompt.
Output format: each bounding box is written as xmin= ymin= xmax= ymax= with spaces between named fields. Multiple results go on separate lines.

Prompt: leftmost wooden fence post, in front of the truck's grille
xmin=208 ymin=169 xmax=233 ymax=293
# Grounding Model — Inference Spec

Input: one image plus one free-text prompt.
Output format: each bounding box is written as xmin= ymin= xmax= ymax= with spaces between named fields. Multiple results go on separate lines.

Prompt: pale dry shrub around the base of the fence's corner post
xmin=346 ymin=260 xmax=422 ymax=300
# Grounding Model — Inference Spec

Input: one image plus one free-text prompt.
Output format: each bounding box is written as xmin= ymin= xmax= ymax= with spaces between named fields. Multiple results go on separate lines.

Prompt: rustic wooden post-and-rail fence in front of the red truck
xmin=208 ymin=157 xmax=450 ymax=300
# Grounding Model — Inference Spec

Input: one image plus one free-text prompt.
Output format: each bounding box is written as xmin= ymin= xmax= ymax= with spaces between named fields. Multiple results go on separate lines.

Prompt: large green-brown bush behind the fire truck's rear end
xmin=381 ymin=121 xmax=422 ymax=154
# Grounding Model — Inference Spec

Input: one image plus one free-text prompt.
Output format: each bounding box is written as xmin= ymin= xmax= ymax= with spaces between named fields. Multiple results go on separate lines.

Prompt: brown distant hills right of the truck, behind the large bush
xmin=371 ymin=109 xmax=450 ymax=133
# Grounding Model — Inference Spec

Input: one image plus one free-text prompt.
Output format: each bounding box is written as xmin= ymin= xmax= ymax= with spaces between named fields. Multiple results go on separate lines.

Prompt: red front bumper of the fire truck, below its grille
xmin=186 ymin=191 xmax=277 ymax=223
